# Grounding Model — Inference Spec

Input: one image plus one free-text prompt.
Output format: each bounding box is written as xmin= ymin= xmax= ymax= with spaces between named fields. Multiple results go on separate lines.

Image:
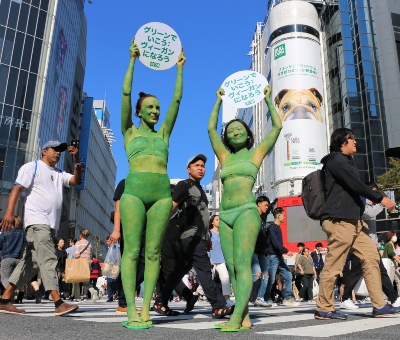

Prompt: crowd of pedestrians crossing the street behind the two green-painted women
xmin=0 ymin=129 xmax=400 ymax=328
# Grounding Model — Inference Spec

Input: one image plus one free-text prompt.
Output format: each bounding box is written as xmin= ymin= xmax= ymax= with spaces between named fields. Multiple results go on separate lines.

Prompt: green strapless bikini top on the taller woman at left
xmin=126 ymin=136 xmax=168 ymax=162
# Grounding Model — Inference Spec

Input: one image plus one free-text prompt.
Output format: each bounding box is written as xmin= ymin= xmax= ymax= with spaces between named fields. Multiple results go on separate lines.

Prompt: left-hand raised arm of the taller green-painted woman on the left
xmin=121 ymin=38 xmax=139 ymax=136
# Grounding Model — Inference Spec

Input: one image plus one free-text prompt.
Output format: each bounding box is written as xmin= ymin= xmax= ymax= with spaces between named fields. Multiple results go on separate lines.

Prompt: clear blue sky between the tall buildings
xmin=84 ymin=0 xmax=267 ymax=185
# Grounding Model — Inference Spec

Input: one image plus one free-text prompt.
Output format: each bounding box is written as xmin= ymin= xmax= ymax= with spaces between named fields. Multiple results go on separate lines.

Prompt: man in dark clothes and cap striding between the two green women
xmin=153 ymin=154 xmax=234 ymax=318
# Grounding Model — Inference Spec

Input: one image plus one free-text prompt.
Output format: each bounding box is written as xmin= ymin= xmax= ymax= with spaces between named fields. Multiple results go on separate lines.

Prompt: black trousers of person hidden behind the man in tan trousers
xmin=342 ymin=254 xmax=397 ymax=303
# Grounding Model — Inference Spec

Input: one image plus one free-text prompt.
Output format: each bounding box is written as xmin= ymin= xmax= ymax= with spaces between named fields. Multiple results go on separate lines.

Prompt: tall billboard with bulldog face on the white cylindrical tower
xmin=271 ymin=38 xmax=327 ymax=181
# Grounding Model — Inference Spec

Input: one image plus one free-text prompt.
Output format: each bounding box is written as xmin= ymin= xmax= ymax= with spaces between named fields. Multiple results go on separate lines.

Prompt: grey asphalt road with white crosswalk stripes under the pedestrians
xmin=0 ymin=298 xmax=400 ymax=340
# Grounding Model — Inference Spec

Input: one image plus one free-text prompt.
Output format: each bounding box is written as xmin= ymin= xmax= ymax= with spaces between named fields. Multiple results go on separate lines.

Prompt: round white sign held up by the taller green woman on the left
xmin=135 ymin=22 xmax=182 ymax=70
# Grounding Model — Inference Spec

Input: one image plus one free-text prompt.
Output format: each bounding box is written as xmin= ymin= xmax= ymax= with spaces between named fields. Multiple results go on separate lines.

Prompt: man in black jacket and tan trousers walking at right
xmin=314 ymin=128 xmax=400 ymax=320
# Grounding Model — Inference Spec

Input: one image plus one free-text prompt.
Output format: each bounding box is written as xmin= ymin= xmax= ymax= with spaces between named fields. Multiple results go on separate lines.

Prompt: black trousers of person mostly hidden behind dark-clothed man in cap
xmin=156 ymin=238 xmax=193 ymax=301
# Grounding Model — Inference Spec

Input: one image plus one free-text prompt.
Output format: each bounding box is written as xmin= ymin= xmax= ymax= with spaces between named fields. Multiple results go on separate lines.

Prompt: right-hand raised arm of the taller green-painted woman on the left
xmin=161 ymin=48 xmax=186 ymax=139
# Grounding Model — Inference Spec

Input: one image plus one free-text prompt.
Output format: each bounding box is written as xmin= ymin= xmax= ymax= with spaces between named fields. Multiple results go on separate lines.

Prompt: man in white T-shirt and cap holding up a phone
xmin=0 ymin=141 xmax=82 ymax=315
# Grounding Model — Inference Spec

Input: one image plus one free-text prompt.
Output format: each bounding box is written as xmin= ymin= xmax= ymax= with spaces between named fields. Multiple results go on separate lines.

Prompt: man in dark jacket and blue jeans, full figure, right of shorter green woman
xmin=264 ymin=208 xmax=300 ymax=306
